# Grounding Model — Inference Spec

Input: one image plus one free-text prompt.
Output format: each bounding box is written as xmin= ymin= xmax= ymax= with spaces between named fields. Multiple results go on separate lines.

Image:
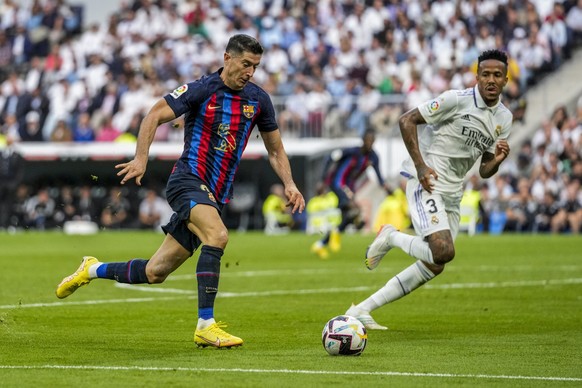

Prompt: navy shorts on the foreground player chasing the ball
xmin=162 ymin=174 xmax=224 ymax=254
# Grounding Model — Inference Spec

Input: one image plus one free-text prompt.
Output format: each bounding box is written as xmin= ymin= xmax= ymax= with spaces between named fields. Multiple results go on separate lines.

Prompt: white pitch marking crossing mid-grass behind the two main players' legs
xmin=0 ymin=278 xmax=582 ymax=310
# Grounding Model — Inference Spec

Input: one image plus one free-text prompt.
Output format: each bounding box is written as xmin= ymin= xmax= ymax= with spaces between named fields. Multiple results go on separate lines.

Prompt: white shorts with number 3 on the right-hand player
xmin=406 ymin=177 xmax=461 ymax=240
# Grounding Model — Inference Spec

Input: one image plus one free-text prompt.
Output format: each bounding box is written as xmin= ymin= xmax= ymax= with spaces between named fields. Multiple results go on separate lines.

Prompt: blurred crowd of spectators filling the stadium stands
xmin=0 ymin=0 xmax=582 ymax=231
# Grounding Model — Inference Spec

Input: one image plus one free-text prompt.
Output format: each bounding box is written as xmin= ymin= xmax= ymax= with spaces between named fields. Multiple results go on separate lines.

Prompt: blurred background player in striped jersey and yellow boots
xmin=311 ymin=129 xmax=390 ymax=259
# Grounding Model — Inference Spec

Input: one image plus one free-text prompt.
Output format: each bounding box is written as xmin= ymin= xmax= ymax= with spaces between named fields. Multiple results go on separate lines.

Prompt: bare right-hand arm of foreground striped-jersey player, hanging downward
xmin=261 ymin=129 xmax=305 ymax=213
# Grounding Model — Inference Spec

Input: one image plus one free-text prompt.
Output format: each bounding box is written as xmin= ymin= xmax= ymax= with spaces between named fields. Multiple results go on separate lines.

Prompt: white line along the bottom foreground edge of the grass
xmin=0 ymin=365 xmax=582 ymax=381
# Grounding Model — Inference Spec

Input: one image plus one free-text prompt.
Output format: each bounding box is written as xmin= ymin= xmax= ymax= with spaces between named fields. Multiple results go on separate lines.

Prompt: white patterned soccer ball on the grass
xmin=321 ymin=315 xmax=368 ymax=356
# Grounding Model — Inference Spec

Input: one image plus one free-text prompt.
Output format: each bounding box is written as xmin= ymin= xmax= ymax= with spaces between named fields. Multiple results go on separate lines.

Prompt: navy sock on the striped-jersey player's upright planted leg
xmin=196 ymin=245 xmax=224 ymax=319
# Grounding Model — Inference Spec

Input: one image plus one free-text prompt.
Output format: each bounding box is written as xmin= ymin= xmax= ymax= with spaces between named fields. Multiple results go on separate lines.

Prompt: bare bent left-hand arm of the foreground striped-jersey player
xmin=115 ymin=98 xmax=176 ymax=186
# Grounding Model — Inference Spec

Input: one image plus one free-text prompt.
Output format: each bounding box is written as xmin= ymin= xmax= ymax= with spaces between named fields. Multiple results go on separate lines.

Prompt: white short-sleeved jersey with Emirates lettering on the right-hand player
xmin=402 ymin=86 xmax=513 ymax=195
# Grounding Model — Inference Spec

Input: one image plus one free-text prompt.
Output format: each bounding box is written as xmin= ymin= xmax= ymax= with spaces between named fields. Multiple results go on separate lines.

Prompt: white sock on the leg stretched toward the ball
xmin=358 ymin=260 xmax=435 ymax=312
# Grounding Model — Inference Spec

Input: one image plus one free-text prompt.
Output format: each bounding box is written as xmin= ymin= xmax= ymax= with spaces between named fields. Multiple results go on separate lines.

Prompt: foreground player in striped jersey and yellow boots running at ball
xmin=57 ymin=34 xmax=305 ymax=347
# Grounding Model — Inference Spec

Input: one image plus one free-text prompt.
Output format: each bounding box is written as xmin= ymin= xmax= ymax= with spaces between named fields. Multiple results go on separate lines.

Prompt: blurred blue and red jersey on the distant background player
xmin=323 ymin=147 xmax=384 ymax=191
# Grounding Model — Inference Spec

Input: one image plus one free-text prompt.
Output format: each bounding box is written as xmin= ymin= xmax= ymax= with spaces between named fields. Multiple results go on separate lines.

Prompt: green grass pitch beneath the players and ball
xmin=0 ymin=232 xmax=582 ymax=387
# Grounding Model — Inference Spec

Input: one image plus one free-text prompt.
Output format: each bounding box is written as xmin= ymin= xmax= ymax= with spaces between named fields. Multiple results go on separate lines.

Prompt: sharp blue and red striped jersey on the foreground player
xmin=164 ymin=68 xmax=278 ymax=203
